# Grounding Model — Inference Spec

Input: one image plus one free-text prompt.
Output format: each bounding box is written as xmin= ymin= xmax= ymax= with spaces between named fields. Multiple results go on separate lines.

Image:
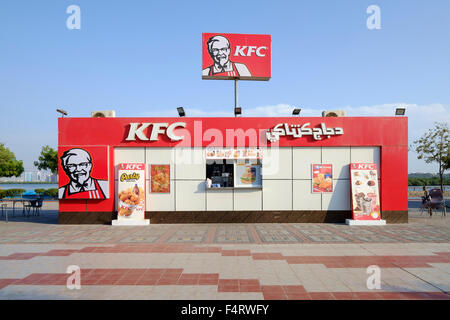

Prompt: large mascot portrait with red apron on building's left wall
xmin=59 ymin=148 xmax=109 ymax=199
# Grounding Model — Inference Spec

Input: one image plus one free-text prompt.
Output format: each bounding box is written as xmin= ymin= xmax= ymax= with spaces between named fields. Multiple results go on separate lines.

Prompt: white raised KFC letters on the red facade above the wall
xmin=125 ymin=122 xmax=186 ymax=141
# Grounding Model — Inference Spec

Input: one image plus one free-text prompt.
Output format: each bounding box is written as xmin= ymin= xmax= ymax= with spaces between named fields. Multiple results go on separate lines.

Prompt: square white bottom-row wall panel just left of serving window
xmin=175 ymin=180 xmax=206 ymax=211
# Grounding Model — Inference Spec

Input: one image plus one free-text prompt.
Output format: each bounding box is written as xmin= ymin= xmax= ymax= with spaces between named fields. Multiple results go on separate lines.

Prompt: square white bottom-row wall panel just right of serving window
xmin=263 ymin=180 xmax=292 ymax=210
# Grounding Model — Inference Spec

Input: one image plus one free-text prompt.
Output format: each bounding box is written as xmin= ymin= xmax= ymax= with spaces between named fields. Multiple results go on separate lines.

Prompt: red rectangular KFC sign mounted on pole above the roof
xmin=202 ymin=33 xmax=272 ymax=80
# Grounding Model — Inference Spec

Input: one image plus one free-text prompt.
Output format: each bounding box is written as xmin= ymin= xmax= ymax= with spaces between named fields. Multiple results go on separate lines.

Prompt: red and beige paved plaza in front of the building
xmin=0 ymin=201 xmax=450 ymax=300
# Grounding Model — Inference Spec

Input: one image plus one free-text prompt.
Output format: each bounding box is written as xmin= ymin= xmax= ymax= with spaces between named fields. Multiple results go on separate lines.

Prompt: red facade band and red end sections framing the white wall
xmin=58 ymin=117 xmax=408 ymax=212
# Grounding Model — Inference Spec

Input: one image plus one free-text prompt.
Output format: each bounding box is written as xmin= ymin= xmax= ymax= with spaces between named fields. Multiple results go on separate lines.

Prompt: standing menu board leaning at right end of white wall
xmin=350 ymin=163 xmax=381 ymax=220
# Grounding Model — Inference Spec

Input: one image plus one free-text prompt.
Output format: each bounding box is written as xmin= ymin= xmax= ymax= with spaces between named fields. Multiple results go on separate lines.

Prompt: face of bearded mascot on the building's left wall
xmin=61 ymin=149 xmax=92 ymax=185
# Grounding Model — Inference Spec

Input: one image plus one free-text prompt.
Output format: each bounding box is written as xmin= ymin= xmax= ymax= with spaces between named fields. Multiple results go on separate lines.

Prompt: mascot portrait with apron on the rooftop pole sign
xmin=202 ymin=36 xmax=252 ymax=78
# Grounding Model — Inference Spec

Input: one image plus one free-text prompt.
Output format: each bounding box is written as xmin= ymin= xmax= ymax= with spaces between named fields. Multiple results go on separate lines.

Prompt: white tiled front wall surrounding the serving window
xmin=114 ymin=147 xmax=380 ymax=211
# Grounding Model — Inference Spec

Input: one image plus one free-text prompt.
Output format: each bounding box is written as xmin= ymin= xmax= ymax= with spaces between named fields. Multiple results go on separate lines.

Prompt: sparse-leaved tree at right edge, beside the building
xmin=413 ymin=123 xmax=450 ymax=192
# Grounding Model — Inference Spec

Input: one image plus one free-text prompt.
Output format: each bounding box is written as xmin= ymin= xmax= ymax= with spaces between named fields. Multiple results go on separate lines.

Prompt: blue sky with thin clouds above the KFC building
xmin=0 ymin=0 xmax=450 ymax=172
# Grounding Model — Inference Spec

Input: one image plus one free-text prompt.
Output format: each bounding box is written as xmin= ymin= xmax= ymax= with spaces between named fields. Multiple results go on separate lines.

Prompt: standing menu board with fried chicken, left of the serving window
xmin=117 ymin=163 xmax=145 ymax=221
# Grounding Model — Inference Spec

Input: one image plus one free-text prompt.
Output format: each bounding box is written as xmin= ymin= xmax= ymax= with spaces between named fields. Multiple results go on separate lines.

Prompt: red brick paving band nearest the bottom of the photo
xmin=0 ymin=269 xmax=450 ymax=300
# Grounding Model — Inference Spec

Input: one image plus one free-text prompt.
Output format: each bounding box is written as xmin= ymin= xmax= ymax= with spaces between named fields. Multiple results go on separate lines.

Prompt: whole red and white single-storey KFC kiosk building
xmin=58 ymin=116 xmax=408 ymax=224
